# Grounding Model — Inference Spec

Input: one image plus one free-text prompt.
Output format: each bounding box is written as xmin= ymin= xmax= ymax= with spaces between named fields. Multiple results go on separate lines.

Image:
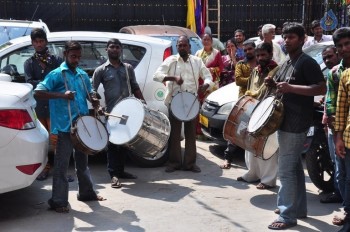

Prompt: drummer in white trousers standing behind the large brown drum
xmin=237 ymin=42 xmax=278 ymax=190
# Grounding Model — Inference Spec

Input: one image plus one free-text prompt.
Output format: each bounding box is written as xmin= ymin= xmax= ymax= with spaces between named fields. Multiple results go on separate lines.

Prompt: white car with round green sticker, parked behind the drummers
xmin=0 ymin=31 xmax=172 ymax=167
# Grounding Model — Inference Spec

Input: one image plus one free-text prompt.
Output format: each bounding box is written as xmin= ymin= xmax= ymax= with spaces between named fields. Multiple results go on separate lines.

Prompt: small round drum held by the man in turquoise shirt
xmin=71 ymin=116 xmax=108 ymax=155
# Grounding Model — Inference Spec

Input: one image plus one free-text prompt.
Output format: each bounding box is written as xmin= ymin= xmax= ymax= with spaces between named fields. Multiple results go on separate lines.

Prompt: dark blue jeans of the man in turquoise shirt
xmin=49 ymin=132 xmax=96 ymax=208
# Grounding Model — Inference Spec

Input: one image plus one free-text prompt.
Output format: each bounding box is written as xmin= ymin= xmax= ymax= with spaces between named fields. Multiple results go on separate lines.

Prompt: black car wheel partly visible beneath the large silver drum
xmin=129 ymin=145 xmax=169 ymax=168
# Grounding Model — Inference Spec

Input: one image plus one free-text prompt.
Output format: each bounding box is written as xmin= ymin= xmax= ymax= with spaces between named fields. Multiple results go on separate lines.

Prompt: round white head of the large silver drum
xmin=107 ymin=97 xmax=145 ymax=145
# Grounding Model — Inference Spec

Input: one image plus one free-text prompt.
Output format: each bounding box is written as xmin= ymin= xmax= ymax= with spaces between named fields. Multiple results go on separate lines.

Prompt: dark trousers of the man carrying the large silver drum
xmin=107 ymin=143 xmax=128 ymax=178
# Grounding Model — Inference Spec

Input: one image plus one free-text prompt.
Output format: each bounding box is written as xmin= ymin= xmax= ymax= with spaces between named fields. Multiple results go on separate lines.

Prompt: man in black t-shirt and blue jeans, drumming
xmin=265 ymin=23 xmax=326 ymax=230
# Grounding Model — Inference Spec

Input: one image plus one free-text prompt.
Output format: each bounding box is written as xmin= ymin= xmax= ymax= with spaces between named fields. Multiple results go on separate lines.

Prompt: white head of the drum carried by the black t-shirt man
xmin=247 ymin=97 xmax=275 ymax=133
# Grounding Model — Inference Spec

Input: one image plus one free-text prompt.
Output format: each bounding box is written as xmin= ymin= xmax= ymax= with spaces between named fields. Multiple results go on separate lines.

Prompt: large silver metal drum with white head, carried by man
xmin=107 ymin=97 xmax=170 ymax=157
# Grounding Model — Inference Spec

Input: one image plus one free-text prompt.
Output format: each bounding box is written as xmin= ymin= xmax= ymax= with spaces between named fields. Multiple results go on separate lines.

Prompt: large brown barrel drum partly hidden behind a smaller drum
xmin=224 ymin=96 xmax=278 ymax=160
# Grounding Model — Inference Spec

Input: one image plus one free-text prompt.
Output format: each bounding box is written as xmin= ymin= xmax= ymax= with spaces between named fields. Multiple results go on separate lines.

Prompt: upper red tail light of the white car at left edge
xmin=0 ymin=110 xmax=35 ymax=130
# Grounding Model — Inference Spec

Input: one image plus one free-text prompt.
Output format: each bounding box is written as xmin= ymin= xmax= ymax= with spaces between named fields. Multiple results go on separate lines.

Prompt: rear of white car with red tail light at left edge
xmin=0 ymin=81 xmax=49 ymax=193
